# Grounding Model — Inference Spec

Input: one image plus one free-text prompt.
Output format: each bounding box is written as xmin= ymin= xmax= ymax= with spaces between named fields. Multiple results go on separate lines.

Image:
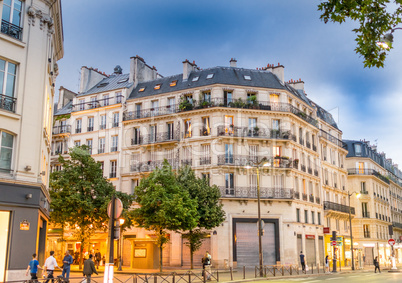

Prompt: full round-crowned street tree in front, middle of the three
xmin=133 ymin=159 xmax=199 ymax=272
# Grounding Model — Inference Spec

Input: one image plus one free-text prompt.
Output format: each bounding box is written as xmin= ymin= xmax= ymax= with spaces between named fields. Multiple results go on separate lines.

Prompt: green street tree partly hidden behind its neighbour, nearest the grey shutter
xmin=177 ymin=166 xmax=225 ymax=269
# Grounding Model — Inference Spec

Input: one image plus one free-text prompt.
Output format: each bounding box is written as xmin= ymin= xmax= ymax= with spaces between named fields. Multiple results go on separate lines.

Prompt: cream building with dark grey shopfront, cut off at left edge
xmin=0 ymin=0 xmax=64 ymax=281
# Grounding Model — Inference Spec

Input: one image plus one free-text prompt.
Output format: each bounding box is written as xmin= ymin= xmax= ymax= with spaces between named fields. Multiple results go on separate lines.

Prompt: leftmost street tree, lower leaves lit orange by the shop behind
xmin=50 ymin=148 xmax=133 ymax=269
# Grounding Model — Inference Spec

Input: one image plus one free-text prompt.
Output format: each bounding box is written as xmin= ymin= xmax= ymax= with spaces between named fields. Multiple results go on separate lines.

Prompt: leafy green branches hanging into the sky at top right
xmin=318 ymin=0 xmax=402 ymax=68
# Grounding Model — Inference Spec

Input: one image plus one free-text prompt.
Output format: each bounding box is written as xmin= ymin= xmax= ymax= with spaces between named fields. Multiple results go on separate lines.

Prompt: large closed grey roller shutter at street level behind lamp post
xmin=235 ymin=222 xmax=276 ymax=267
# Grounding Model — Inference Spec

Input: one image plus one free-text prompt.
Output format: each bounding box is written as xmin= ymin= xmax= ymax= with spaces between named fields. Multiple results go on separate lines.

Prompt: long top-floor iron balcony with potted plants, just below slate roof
xmin=123 ymin=98 xmax=318 ymax=127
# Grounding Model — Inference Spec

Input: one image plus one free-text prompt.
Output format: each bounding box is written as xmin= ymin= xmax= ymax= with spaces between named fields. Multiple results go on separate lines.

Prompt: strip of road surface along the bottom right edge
xmin=258 ymin=271 xmax=402 ymax=283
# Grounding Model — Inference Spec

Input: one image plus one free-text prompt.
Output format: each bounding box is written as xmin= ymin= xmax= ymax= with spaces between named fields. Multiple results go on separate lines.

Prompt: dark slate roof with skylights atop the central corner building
xmin=128 ymin=67 xmax=289 ymax=99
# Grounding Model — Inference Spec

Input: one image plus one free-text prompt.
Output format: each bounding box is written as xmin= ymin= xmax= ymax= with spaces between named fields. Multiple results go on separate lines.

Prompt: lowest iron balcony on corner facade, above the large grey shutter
xmin=220 ymin=187 xmax=295 ymax=199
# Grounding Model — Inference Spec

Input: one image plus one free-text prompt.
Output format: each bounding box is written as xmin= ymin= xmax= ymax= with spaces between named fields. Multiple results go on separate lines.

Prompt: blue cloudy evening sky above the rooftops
xmin=56 ymin=0 xmax=402 ymax=166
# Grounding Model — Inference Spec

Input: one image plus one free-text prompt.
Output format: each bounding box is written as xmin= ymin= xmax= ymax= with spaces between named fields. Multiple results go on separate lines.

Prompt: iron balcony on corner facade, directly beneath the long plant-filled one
xmin=218 ymin=126 xmax=294 ymax=140
